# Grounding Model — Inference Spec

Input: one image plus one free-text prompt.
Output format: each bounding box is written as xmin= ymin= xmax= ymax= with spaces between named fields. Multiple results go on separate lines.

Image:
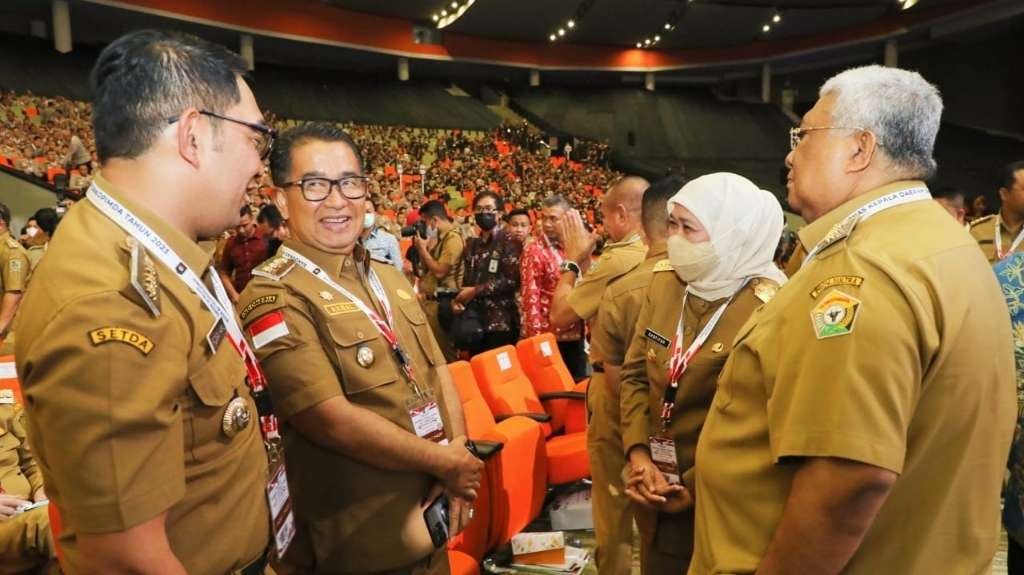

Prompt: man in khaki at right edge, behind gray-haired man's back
xmin=971 ymin=162 xmax=1024 ymax=264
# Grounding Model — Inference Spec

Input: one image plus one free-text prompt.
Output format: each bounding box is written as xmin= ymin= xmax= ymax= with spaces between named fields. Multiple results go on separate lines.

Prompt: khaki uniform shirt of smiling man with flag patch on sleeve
xmin=239 ymin=240 xmax=452 ymax=573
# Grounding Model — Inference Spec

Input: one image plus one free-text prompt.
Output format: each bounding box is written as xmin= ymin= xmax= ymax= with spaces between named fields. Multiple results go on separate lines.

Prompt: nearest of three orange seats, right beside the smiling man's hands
xmin=449 ymin=361 xmax=548 ymax=544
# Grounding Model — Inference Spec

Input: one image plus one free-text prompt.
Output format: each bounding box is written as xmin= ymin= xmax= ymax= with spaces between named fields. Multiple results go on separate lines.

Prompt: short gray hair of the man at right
xmin=819 ymin=65 xmax=942 ymax=180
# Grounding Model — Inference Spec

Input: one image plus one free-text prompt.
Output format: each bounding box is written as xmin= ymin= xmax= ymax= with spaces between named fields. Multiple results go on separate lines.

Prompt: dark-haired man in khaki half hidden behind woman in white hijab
xmin=590 ymin=177 xmax=685 ymax=573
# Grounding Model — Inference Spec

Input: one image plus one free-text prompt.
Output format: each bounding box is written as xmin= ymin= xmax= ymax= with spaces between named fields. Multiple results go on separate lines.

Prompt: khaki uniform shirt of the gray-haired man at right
xmin=690 ymin=182 xmax=1017 ymax=575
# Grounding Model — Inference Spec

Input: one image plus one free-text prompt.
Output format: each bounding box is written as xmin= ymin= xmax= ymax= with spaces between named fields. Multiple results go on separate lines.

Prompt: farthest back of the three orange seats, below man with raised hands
xmin=516 ymin=334 xmax=590 ymax=433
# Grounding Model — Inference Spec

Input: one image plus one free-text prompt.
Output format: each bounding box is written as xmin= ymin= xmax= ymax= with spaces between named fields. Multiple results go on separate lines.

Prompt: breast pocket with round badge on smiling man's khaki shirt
xmin=328 ymin=314 xmax=398 ymax=392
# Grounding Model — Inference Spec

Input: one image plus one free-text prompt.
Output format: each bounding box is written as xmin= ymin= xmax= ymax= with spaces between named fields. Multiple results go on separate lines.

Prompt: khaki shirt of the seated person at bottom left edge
xmin=0 ymin=395 xmax=43 ymax=499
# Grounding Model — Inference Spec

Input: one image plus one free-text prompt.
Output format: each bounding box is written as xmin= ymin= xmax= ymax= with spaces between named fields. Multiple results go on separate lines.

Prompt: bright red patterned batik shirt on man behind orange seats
xmin=519 ymin=236 xmax=583 ymax=342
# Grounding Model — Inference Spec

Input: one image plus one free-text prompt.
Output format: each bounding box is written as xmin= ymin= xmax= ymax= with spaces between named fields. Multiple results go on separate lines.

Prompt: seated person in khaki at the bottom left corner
xmin=0 ymin=390 xmax=56 ymax=573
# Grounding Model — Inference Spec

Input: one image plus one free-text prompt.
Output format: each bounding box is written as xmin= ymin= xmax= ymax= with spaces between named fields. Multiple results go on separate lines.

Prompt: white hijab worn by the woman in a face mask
xmin=668 ymin=172 xmax=786 ymax=302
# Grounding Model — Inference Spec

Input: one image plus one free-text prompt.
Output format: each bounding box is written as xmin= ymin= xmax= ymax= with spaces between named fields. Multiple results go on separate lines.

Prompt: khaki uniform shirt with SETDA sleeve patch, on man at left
xmin=15 ymin=178 xmax=269 ymax=575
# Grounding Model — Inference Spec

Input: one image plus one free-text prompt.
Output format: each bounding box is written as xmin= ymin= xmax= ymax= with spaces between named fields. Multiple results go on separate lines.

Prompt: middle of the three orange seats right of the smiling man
xmin=470 ymin=346 xmax=590 ymax=485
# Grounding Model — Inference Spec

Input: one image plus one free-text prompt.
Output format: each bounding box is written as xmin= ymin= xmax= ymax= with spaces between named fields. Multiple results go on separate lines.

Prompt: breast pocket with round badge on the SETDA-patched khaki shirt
xmin=185 ymin=349 xmax=246 ymax=452
